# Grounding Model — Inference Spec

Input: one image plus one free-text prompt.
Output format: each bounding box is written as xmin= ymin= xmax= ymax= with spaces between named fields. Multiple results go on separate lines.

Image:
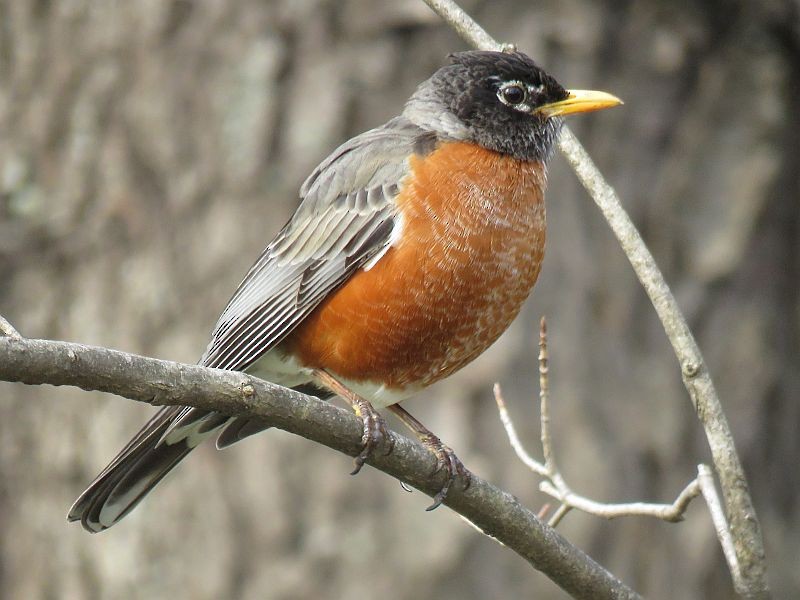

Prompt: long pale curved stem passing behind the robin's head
xmin=424 ymin=0 xmax=769 ymax=598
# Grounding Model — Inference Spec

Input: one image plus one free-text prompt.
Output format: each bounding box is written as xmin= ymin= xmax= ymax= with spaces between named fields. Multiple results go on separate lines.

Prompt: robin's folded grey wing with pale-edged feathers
xmin=201 ymin=117 xmax=430 ymax=370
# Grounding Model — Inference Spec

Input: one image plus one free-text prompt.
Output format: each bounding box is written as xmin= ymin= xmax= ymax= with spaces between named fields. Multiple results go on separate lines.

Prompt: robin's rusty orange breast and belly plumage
xmin=282 ymin=142 xmax=545 ymax=389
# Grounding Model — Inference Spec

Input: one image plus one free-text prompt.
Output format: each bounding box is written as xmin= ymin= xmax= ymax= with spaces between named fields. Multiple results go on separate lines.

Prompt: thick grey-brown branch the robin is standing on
xmin=0 ymin=337 xmax=639 ymax=598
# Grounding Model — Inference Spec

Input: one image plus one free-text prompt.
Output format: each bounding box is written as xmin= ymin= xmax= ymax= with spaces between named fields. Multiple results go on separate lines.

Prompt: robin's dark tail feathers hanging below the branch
xmin=67 ymin=406 xmax=238 ymax=533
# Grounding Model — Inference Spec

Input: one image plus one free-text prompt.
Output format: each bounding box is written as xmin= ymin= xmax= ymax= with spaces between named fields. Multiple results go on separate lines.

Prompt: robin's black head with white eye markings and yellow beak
xmin=403 ymin=51 xmax=621 ymax=160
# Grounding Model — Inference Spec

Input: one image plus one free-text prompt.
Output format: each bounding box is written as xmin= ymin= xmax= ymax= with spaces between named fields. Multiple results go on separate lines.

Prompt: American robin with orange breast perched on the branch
xmin=69 ymin=52 xmax=620 ymax=532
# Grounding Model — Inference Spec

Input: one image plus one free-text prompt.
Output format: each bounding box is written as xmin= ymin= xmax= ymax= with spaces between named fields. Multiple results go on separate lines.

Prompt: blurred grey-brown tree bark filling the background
xmin=0 ymin=0 xmax=800 ymax=599
